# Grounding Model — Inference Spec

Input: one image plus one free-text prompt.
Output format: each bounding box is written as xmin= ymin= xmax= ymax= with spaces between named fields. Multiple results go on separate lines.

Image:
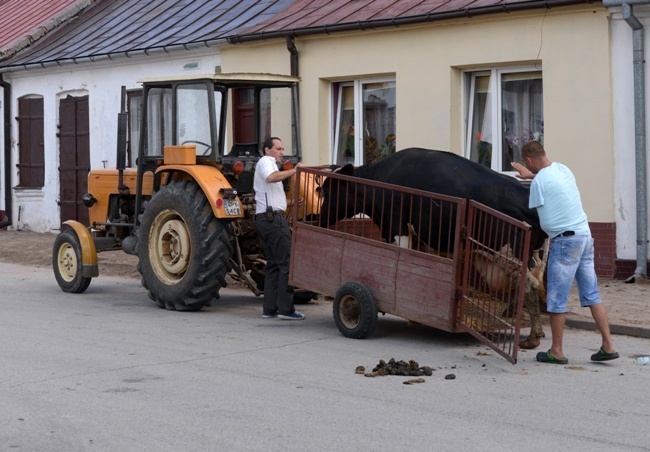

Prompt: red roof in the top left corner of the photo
xmin=0 ymin=0 xmax=94 ymax=58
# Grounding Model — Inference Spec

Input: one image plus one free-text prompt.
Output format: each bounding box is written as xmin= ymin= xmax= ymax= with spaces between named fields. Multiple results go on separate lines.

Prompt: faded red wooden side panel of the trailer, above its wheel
xmin=291 ymin=223 xmax=456 ymax=331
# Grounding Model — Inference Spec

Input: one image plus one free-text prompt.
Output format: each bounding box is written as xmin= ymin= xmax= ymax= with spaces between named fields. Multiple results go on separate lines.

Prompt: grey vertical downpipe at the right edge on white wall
xmin=603 ymin=0 xmax=650 ymax=282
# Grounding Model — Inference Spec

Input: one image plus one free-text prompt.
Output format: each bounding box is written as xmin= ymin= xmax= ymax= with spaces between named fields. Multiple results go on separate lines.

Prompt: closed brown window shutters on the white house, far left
xmin=17 ymin=96 xmax=45 ymax=188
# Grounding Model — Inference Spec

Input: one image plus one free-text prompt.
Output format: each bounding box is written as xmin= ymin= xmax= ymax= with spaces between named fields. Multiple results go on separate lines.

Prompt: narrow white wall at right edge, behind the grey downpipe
xmin=611 ymin=6 xmax=650 ymax=260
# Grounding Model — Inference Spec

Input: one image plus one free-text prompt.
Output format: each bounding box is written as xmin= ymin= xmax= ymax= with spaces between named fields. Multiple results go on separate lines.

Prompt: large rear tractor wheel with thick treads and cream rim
xmin=138 ymin=180 xmax=233 ymax=311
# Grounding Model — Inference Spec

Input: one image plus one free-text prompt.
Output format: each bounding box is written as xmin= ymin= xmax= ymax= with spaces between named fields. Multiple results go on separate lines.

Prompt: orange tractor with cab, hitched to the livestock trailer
xmin=52 ymin=73 xmax=318 ymax=311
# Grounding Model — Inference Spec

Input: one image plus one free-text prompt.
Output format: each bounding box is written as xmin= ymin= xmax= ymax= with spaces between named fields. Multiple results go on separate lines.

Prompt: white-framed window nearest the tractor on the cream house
xmin=332 ymin=80 xmax=396 ymax=165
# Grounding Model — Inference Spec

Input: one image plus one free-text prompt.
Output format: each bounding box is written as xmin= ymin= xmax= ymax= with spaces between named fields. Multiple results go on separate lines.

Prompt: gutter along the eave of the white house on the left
xmin=0 ymin=38 xmax=227 ymax=74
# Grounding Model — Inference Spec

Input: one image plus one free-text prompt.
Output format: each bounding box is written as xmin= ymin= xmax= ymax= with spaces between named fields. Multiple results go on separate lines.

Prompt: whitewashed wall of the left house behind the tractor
xmin=0 ymin=48 xmax=221 ymax=232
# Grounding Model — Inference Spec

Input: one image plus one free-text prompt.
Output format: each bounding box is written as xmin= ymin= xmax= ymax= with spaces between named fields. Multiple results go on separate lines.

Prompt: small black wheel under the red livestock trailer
xmin=333 ymin=281 xmax=377 ymax=339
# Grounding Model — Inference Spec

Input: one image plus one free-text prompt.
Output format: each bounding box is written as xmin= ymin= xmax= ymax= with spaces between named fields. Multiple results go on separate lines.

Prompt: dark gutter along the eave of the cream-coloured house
xmin=227 ymin=0 xmax=594 ymax=44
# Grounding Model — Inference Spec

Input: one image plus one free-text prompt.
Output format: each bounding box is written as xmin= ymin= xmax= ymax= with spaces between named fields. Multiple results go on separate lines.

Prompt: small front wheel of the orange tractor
xmin=52 ymin=229 xmax=92 ymax=293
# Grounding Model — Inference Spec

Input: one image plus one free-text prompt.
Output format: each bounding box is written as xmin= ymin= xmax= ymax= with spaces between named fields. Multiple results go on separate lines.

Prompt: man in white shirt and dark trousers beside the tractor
xmin=253 ymin=137 xmax=305 ymax=320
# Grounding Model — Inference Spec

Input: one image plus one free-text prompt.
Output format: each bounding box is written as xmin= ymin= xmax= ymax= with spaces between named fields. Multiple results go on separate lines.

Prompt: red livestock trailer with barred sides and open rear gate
xmin=290 ymin=167 xmax=530 ymax=364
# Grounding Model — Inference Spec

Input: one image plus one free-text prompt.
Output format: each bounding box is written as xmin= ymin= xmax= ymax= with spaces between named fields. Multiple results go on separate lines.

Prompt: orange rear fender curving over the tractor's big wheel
xmin=156 ymin=165 xmax=244 ymax=218
